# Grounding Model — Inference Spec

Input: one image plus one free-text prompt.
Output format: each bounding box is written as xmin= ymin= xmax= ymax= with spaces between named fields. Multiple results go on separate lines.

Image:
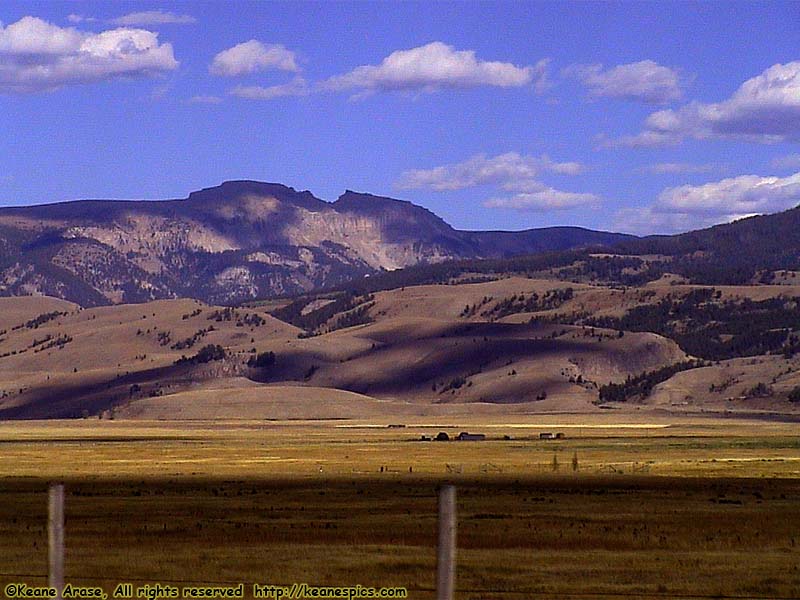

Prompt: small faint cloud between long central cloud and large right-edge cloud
xmin=564 ymin=60 xmax=682 ymax=104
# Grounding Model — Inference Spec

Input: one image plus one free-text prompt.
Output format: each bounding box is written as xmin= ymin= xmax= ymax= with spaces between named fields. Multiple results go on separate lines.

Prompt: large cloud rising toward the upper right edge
xmin=612 ymin=61 xmax=800 ymax=147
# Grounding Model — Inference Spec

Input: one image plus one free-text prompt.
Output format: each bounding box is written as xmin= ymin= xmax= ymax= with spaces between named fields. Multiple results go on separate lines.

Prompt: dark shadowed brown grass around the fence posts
xmin=0 ymin=478 xmax=800 ymax=598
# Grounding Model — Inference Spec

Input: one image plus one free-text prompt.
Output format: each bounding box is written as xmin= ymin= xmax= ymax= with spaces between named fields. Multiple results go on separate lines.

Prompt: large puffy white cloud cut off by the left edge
xmin=0 ymin=17 xmax=178 ymax=93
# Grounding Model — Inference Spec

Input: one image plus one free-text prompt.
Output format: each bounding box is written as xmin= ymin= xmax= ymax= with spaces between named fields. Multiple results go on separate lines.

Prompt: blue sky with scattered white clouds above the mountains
xmin=0 ymin=0 xmax=800 ymax=234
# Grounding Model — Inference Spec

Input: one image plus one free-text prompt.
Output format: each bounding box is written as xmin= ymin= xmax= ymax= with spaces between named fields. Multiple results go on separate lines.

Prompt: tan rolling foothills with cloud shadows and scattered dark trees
xmin=0 ymin=276 xmax=800 ymax=419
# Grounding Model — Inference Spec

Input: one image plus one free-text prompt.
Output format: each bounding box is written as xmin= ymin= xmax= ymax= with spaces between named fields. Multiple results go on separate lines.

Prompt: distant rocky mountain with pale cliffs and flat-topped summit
xmin=0 ymin=181 xmax=633 ymax=306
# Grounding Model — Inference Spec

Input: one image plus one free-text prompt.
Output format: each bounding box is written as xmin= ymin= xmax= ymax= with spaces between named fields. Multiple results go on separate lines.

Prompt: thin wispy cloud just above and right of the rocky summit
xmin=396 ymin=152 xmax=584 ymax=192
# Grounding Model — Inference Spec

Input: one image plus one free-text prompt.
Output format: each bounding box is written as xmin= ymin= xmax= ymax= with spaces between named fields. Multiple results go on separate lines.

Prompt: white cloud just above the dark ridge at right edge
xmin=655 ymin=173 xmax=800 ymax=219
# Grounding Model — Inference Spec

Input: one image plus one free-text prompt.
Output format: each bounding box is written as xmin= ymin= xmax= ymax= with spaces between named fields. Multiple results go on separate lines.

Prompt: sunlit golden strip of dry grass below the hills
xmin=0 ymin=414 xmax=800 ymax=479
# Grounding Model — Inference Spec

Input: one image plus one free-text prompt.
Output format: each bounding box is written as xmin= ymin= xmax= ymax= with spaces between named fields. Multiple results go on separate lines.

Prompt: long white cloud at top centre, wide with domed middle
xmin=323 ymin=42 xmax=548 ymax=93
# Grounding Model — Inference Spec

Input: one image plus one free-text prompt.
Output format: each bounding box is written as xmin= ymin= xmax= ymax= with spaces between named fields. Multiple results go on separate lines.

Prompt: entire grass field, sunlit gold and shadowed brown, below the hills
xmin=0 ymin=412 xmax=800 ymax=599
